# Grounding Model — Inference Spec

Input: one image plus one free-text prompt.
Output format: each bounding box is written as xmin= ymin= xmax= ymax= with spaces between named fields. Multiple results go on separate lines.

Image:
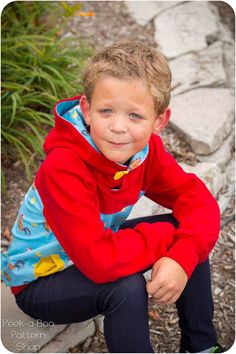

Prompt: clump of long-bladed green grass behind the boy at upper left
xmin=2 ymin=1 xmax=92 ymax=184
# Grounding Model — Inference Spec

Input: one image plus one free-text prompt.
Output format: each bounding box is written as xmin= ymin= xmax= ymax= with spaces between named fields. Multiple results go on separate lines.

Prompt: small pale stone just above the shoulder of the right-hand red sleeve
xmin=180 ymin=162 xmax=225 ymax=197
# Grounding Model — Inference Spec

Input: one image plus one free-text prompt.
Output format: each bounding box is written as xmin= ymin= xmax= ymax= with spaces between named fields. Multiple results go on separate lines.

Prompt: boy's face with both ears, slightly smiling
xmin=80 ymin=77 xmax=170 ymax=164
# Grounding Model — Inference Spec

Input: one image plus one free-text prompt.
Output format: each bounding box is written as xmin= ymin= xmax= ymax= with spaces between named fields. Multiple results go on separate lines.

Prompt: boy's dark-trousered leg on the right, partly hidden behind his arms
xmin=123 ymin=214 xmax=217 ymax=352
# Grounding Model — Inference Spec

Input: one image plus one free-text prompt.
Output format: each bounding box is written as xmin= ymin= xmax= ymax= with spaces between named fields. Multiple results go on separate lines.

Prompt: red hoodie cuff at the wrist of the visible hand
xmin=165 ymin=239 xmax=199 ymax=278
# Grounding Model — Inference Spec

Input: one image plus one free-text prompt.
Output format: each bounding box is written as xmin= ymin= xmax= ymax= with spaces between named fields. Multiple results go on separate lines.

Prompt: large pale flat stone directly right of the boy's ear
xmin=170 ymin=88 xmax=234 ymax=155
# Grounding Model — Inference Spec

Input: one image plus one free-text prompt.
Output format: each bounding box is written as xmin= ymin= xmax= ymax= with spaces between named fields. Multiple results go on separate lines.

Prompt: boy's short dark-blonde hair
xmin=83 ymin=41 xmax=171 ymax=115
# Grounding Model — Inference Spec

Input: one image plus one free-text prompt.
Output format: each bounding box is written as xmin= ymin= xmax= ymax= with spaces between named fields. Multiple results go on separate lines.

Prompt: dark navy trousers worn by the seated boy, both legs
xmin=16 ymin=214 xmax=216 ymax=353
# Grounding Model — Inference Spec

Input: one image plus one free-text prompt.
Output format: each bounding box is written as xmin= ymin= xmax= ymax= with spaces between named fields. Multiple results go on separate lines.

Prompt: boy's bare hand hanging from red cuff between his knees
xmin=146 ymin=257 xmax=188 ymax=305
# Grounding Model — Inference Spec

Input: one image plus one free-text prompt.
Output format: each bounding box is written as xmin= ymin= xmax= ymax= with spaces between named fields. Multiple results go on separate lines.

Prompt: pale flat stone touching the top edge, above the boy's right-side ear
xmin=155 ymin=1 xmax=219 ymax=58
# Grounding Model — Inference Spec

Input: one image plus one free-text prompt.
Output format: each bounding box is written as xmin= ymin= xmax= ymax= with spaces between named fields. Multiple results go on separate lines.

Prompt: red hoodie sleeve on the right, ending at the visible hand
xmin=145 ymin=136 xmax=220 ymax=277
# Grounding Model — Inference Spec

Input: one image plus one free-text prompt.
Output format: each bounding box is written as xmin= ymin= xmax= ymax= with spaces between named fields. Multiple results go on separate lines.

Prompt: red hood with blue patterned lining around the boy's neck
xmin=44 ymin=96 xmax=149 ymax=180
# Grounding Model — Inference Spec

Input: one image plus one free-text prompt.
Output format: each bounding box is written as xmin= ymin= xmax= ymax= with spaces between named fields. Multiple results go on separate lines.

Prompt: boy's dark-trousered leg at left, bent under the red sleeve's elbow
xmin=16 ymin=265 xmax=153 ymax=353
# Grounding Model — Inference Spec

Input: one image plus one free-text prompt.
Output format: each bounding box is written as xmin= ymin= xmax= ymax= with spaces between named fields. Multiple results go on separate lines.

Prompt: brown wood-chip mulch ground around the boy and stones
xmin=2 ymin=1 xmax=235 ymax=353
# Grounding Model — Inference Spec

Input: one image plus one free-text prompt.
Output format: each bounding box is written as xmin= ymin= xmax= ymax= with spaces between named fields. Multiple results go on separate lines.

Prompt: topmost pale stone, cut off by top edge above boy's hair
xmin=125 ymin=1 xmax=178 ymax=26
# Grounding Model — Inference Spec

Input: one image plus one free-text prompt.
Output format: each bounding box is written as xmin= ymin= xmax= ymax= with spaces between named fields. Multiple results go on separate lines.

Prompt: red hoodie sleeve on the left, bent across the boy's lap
xmin=35 ymin=148 xmax=174 ymax=283
